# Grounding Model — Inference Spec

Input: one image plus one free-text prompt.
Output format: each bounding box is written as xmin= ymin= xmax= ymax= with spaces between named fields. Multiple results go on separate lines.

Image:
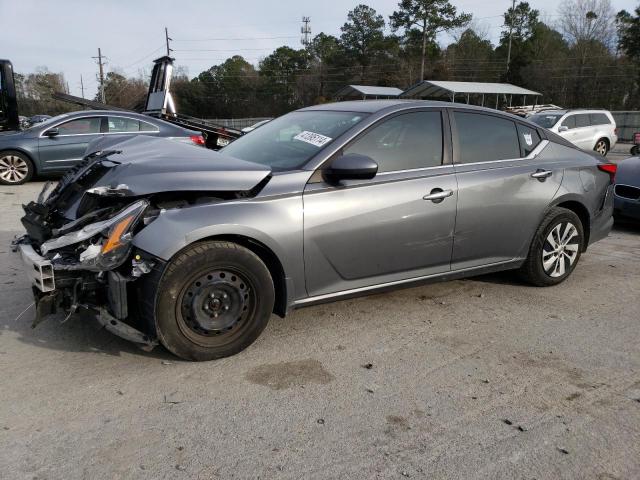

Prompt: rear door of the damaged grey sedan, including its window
xmin=451 ymin=110 xmax=563 ymax=270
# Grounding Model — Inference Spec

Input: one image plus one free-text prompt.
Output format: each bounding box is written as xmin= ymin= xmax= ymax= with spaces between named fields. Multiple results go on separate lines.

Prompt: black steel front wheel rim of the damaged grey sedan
xmin=178 ymin=269 xmax=255 ymax=346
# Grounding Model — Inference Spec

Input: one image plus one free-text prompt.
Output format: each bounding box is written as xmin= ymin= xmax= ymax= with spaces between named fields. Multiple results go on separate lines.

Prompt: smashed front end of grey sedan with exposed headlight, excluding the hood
xmin=13 ymin=152 xmax=160 ymax=349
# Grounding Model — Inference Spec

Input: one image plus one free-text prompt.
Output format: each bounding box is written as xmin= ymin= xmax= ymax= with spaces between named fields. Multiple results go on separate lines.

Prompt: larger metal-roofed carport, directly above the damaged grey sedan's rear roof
xmin=400 ymin=80 xmax=542 ymax=108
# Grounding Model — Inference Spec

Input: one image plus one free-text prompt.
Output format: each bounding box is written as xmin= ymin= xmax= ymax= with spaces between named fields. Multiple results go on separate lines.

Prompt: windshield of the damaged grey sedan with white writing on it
xmin=222 ymin=110 xmax=366 ymax=170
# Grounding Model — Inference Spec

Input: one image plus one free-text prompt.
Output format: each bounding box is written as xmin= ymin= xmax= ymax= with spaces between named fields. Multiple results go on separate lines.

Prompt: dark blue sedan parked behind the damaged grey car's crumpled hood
xmin=0 ymin=110 xmax=204 ymax=185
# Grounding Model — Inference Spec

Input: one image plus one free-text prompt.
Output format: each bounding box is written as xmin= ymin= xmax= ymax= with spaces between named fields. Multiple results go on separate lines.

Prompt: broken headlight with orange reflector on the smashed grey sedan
xmin=40 ymin=200 xmax=149 ymax=270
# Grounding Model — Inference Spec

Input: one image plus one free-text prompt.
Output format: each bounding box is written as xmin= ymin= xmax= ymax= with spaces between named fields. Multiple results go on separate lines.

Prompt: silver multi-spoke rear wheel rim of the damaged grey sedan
xmin=542 ymin=222 xmax=580 ymax=278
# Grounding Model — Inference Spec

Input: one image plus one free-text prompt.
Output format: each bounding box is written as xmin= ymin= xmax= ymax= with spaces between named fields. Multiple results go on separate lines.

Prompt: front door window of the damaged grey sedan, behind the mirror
xmin=343 ymin=111 xmax=443 ymax=173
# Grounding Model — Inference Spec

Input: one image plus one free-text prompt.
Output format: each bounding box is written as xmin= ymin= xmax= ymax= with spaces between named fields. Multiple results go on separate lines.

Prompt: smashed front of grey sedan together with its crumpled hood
xmin=13 ymin=137 xmax=270 ymax=349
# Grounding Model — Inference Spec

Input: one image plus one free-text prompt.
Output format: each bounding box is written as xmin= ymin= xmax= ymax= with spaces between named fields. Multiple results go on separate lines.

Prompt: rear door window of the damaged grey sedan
xmin=453 ymin=112 xmax=521 ymax=163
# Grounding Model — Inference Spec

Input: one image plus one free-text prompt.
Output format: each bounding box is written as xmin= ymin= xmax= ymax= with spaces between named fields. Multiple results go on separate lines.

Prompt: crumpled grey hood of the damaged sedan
xmin=85 ymin=135 xmax=271 ymax=196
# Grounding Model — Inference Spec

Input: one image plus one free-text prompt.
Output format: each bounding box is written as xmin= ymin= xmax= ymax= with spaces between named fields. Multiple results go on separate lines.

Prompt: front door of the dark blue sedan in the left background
xmin=38 ymin=116 xmax=106 ymax=170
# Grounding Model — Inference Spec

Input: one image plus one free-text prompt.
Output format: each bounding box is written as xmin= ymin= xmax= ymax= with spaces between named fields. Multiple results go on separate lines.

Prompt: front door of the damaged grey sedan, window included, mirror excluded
xmin=303 ymin=110 xmax=457 ymax=296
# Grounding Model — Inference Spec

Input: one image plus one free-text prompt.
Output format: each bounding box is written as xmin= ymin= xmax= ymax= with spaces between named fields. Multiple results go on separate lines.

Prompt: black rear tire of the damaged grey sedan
xmin=520 ymin=207 xmax=584 ymax=287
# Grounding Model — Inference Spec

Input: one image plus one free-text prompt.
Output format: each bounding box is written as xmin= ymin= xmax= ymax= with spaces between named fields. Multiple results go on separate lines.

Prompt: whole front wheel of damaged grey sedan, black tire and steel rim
xmin=143 ymin=241 xmax=275 ymax=361
